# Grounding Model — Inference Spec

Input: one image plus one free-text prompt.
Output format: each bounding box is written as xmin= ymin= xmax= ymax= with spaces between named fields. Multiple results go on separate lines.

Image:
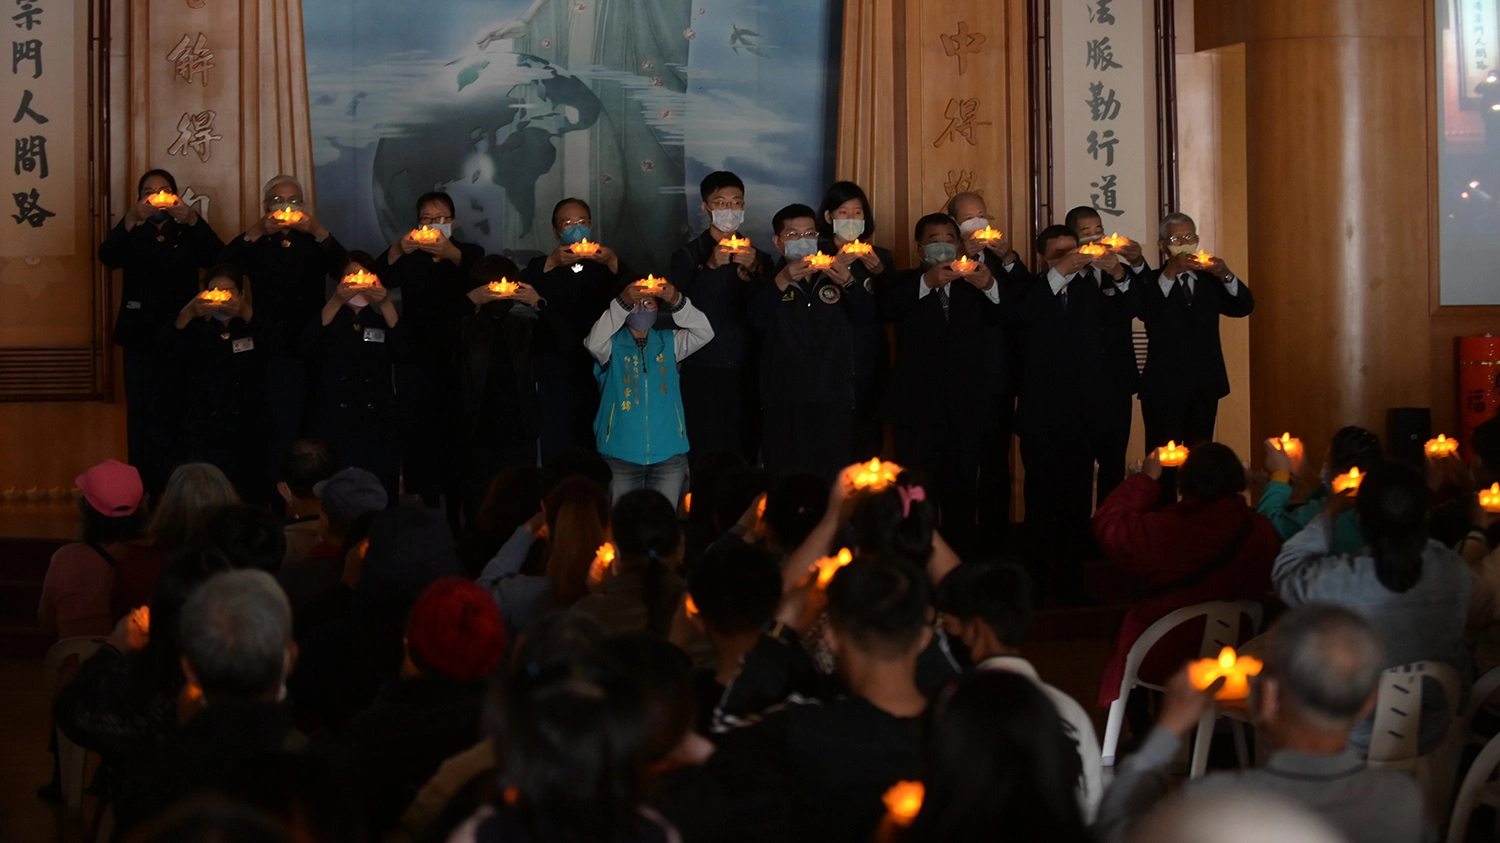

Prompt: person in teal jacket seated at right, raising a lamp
xmin=1256 ymin=426 xmax=1382 ymax=554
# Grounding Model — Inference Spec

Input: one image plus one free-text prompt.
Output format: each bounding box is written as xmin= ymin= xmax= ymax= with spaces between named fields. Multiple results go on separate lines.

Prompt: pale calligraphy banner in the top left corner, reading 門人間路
xmin=0 ymin=0 xmax=89 ymax=258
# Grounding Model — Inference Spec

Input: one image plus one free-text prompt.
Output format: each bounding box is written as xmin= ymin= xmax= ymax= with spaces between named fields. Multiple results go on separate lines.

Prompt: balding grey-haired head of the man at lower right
xmin=1266 ymin=605 xmax=1385 ymax=723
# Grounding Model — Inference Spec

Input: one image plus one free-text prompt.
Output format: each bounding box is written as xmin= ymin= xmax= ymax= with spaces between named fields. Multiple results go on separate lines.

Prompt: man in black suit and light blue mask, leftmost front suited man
xmin=881 ymin=213 xmax=1005 ymax=551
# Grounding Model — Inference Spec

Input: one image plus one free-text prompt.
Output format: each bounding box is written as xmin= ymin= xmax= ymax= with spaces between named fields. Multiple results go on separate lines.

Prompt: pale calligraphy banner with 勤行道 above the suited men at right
xmin=1049 ymin=0 xmax=1158 ymax=244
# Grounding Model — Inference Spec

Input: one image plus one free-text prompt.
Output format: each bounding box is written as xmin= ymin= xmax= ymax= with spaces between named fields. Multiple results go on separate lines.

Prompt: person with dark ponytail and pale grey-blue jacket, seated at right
xmin=1271 ymin=462 xmax=1475 ymax=752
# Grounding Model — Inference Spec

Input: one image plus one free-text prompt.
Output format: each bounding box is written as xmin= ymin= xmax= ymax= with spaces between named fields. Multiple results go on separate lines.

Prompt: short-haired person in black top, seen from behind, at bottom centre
xmin=717 ymin=557 xmax=933 ymax=843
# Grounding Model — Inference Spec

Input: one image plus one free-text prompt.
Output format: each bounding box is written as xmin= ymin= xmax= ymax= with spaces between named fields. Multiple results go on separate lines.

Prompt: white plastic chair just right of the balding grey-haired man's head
xmin=1368 ymin=662 xmax=1467 ymax=830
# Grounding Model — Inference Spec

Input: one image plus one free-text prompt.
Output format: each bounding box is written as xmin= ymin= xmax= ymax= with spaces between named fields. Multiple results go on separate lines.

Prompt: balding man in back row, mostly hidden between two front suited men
xmin=948 ymin=192 xmax=1031 ymax=548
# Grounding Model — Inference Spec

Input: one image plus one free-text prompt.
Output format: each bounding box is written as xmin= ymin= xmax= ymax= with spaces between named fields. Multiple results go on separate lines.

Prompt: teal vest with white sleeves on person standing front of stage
xmin=584 ymin=296 xmax=714 ymax=465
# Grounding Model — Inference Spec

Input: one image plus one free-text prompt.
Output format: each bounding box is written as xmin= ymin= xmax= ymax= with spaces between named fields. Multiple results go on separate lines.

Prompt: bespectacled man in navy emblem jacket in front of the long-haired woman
xmin=750 ymin=204 xmax=876 ymax=482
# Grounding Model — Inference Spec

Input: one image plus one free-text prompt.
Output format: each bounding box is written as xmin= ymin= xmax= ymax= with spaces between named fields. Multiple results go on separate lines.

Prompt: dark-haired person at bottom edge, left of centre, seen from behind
xmin=449 ymin=656 xmax=677 ymax=843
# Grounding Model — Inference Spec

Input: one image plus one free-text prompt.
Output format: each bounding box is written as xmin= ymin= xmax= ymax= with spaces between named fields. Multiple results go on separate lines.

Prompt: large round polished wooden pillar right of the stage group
xmin=1236 ymin=0 xmax=1436 ymax=459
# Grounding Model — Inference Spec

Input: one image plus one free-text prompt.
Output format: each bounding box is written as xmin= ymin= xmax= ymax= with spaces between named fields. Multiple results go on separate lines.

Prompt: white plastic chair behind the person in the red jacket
xmin=1101 ymin=600 xmax=1263 ymax=779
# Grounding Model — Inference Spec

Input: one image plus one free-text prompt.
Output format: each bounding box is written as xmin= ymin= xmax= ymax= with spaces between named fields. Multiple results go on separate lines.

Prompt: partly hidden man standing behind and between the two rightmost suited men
xmin=1065 ymin=206 xmax=1151 ymax=506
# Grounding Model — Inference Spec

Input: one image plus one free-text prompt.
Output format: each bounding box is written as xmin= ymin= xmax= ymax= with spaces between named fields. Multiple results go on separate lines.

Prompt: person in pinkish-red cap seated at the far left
xmin=36 ymin=459 xmax=146 ymax=639
